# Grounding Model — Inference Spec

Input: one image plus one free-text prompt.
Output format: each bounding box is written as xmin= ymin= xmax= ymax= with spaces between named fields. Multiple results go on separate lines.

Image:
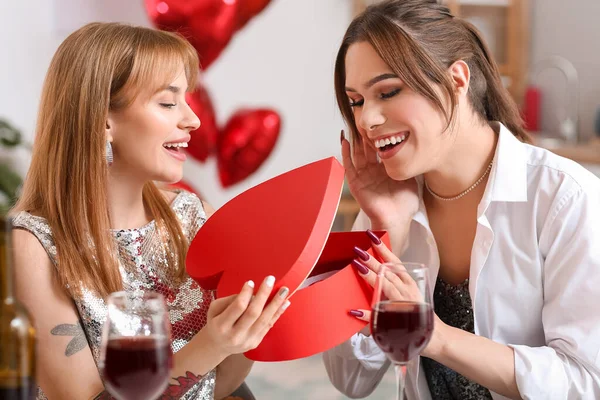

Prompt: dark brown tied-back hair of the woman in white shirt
xmin=334 ymin=0 xmax=530 ymax=142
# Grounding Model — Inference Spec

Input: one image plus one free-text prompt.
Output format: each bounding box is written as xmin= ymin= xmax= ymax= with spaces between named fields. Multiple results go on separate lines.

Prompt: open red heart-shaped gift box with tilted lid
xmin=186 ymin=157 xmax=389 ymax=361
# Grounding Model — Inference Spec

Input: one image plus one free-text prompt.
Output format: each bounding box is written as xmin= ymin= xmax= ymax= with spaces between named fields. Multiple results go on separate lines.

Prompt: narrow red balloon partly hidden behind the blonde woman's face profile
xmin=186 ymin=85 xmax=219 ymax=162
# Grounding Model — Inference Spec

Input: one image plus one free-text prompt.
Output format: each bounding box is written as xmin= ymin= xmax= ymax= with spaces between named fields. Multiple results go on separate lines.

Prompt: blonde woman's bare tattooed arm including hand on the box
xmin=14 ymin=230 xmax=285 ymax=400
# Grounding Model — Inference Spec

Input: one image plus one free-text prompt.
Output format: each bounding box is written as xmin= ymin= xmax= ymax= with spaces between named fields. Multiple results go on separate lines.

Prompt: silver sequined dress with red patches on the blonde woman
xmin=13 ymin=191 xmax=215 ymax=400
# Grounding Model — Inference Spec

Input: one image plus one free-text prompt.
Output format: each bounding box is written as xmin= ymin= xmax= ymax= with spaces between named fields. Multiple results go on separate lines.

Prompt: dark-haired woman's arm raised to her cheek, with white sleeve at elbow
xmin=323 ymin=136 xmax=420 ymax=398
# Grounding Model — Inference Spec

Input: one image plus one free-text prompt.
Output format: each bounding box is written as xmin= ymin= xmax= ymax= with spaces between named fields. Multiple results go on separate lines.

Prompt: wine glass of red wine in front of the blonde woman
xmin=100 ymin=292 xmax=173 ymax=400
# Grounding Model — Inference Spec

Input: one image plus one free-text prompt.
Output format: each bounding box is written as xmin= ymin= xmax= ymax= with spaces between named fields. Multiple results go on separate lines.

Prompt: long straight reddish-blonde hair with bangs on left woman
xmin=15 ymin=23 xmax=198 ymax=296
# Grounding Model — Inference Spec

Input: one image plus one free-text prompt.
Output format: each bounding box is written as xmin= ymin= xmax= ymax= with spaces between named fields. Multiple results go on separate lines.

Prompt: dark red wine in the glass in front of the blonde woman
xmin=104 ymin=336 xmax=172 ymax=400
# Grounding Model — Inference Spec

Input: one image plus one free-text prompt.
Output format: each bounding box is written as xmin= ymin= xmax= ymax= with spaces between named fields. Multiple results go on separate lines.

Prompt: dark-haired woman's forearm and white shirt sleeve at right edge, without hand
xmin=428 ymin=182 xmax=600 ymax=400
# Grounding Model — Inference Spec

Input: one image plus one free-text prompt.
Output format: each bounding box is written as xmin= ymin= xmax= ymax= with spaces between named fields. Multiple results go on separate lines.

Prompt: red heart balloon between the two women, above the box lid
xmin=217 ymin=109 xmax=281 ymax=187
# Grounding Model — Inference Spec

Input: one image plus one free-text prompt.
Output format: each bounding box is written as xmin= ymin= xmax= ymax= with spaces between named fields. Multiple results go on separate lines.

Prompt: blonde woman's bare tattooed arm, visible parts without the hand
xmin=14 ymin=230 xmax=230 ymax=399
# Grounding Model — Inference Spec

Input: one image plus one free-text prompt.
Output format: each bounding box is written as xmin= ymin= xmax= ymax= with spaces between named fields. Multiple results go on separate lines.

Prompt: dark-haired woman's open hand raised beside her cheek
xmin=340 ymin=131 xmax=419 ymax=230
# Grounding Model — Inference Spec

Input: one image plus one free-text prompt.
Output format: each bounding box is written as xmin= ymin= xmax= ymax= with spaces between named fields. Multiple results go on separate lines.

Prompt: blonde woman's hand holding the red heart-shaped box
xmin=202 ymin=276 xmax=290 ymax=357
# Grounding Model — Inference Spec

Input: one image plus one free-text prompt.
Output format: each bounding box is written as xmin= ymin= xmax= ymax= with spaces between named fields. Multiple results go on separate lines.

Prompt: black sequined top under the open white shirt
xmin=421 ymin=277 xmax=492 ymax=400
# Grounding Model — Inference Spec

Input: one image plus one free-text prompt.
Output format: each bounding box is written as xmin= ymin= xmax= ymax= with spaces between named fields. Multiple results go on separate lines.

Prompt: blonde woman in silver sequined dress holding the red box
xmin=13 ymin=23 xmax=289 ymax=399
